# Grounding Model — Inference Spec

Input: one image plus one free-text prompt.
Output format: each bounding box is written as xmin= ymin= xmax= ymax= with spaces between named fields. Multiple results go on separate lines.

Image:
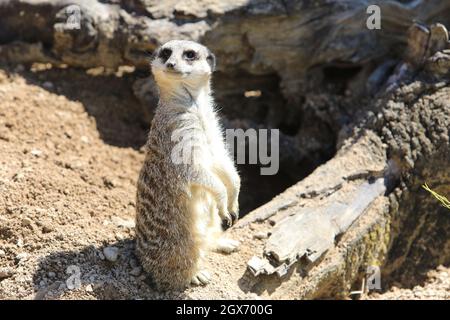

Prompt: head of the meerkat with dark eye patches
xmin=152 ymin=40 xmax=216 ymax=96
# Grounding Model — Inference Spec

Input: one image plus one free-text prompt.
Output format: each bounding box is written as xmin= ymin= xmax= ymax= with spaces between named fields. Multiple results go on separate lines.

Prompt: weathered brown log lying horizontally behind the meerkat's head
xmin=0 ymin=0 xmax=450 ymax=102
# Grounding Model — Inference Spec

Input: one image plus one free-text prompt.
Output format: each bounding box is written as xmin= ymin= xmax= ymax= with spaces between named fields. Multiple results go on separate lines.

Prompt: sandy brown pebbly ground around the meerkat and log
xmin=0 ymin=68 xmax=450 ymax=299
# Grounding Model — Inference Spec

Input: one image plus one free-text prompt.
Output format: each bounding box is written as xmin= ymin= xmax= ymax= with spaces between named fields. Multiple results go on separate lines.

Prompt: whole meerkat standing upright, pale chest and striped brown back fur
xmin=136 ymin=40 xmax=240 ymax=290
